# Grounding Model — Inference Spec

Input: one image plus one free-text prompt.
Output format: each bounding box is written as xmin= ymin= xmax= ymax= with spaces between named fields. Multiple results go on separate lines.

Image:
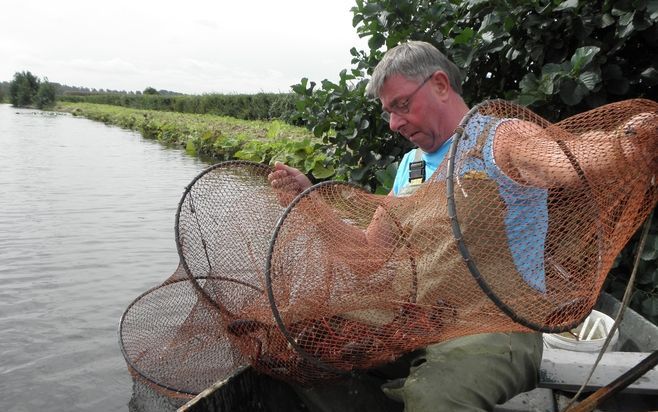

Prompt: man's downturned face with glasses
xmin=379 ymin=75 xmax=445 ymax=153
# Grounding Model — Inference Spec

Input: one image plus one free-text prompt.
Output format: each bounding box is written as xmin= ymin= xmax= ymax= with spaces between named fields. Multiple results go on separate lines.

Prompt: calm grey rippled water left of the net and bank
xmin=0 ymin=105 xmax=207 ymax=412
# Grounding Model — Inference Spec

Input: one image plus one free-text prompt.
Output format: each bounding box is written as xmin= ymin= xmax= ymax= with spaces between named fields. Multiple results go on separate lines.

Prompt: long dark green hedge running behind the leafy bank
xmin=57 ymin=93 xmax=299 ymax=124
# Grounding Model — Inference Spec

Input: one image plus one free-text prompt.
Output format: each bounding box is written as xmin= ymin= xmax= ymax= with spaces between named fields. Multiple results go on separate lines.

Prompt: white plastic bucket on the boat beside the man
xmin=544 ymin=310 xmax=619 ymax=352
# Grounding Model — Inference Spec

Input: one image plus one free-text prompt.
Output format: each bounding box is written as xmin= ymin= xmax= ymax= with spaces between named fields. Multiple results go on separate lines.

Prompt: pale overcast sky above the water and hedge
xmin=0 ymin=0 xmax=367 ymax=94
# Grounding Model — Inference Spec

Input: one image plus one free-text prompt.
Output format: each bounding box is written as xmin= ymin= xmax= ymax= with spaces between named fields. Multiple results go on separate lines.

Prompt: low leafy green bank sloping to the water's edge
xmin=56 ymin=102 xmax=334 ymax=178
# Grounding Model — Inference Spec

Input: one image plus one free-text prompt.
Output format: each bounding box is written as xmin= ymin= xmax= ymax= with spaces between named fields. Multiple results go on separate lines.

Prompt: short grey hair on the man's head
xmin=366 ymin=40 xmax=462 ymax=98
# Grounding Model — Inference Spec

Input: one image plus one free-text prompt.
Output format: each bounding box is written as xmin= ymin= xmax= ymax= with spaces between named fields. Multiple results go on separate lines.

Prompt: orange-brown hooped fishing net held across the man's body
xmin=119 ymin=99 xmax=658 ymax=395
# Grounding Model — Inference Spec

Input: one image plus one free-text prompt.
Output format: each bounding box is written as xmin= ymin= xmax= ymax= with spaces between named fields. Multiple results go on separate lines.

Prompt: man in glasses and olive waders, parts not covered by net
xmin=268 ymin=41 xmax=542 ymax=411
